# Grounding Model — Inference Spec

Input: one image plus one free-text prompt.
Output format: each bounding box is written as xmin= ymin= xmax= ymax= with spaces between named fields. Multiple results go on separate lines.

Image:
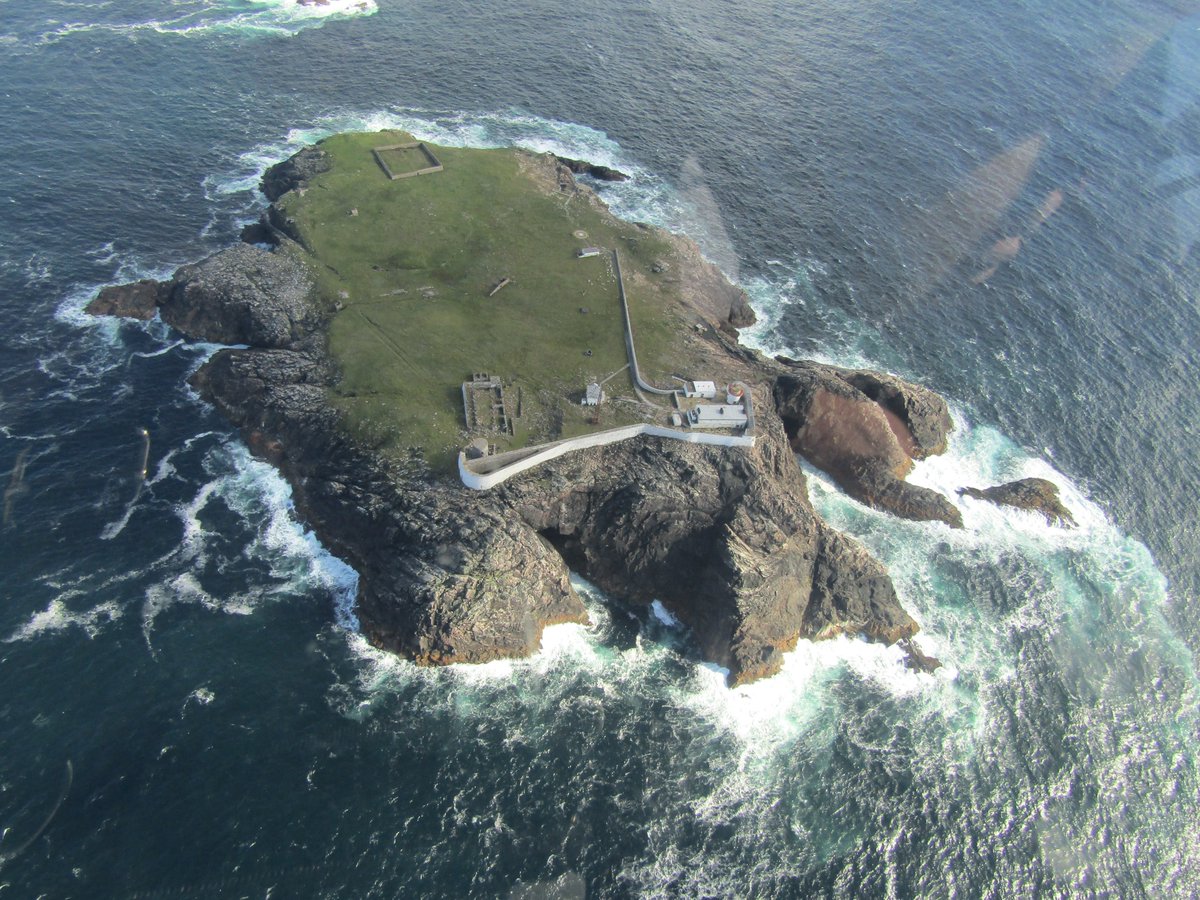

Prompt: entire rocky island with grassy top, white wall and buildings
xmin=90 ymin=132 xmax=998 ymax=684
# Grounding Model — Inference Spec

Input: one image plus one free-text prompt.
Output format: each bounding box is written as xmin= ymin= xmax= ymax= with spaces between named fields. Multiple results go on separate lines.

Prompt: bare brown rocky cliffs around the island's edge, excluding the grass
xmin=88 ymin=151 xmax=958 ymax=683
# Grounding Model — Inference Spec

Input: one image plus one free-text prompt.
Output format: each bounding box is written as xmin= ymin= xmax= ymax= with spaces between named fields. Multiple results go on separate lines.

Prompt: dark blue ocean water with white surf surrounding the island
xmin=0 ymin=0 xmax=1200 ymax=898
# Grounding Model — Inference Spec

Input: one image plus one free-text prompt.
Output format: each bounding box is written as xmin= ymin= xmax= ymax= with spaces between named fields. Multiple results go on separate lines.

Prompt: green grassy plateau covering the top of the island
xmin=280 ymin=132 xmax=710 ymax=480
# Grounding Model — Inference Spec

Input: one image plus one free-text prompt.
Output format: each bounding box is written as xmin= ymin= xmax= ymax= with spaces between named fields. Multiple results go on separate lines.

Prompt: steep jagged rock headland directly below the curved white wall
xmin=499 ymin=398 xmax=917 ymax=683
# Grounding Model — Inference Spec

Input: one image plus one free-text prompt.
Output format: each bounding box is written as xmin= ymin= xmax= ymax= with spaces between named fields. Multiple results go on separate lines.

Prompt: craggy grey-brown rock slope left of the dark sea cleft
xmin=192 ymin=349 xmax=587 ymax=664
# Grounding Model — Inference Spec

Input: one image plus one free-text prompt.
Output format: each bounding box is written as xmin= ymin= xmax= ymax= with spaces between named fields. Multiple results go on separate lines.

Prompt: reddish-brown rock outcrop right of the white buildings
xmin=774 ymin=360 xmax=962 ymax=528
